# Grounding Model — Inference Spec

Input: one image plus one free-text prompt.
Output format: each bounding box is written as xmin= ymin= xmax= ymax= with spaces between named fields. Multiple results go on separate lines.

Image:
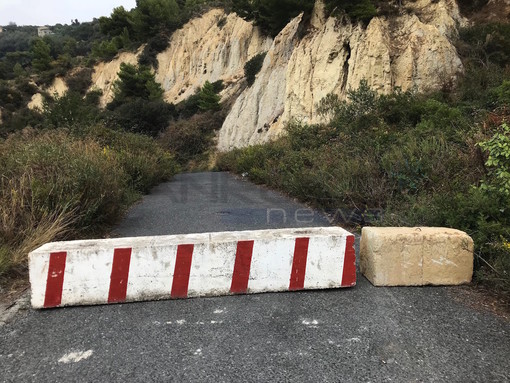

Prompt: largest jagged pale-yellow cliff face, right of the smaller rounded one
xmin=218 ymin=0 xmax=463 ymax=151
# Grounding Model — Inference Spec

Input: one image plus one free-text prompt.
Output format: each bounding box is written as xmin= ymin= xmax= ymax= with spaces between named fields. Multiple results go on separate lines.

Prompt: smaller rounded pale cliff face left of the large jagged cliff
xmin=156 ymin=9 xmax=271 ymax=103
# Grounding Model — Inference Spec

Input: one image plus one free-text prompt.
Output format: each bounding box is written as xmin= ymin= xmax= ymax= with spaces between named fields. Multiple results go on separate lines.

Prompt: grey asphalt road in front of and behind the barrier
xmin=0 ymin=173 xmax=510 ymax=382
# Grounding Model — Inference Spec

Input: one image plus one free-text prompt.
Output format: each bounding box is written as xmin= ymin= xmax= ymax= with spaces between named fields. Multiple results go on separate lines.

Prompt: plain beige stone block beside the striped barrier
xmin=360 ymin=227 xmax=474 ymax=286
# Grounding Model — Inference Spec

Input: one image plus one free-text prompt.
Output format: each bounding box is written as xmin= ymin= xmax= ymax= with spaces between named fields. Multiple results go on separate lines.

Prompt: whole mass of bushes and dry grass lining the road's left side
xmin=0 ymin=127 xmax=176 ymax=276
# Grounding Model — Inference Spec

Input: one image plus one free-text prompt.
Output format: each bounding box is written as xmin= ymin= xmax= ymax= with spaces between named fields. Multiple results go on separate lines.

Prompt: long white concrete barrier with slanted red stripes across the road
xmin=29 ymin=227 xmax=356 ymax=308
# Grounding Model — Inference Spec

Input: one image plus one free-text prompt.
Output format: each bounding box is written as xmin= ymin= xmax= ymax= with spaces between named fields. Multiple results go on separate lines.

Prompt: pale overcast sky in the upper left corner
xmin=0 ymin=0 xmax=136 ymax=25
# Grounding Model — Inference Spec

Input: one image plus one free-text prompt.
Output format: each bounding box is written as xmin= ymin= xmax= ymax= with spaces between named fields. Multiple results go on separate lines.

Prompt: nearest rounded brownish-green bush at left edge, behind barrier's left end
xmin=0 ymin=132 xmax=127 ymax=278
